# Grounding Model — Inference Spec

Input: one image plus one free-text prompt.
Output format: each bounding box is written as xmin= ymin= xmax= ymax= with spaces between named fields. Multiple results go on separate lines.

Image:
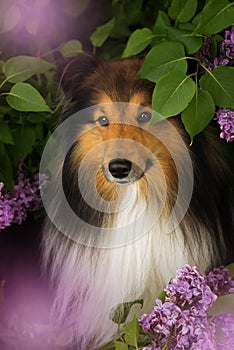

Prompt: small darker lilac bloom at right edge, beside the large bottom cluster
xmin=205 ymin=266 xmax=234 ymax=296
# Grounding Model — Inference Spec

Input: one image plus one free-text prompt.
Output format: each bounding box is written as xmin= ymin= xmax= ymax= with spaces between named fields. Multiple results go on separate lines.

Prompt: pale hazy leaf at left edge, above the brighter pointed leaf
xmin=3 ymin=56 xmax=55 ymax=83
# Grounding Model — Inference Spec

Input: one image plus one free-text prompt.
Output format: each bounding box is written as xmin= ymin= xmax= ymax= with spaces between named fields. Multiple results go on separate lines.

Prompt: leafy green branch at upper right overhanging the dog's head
xmin=88 ymin=0 xmax=234 ymax=143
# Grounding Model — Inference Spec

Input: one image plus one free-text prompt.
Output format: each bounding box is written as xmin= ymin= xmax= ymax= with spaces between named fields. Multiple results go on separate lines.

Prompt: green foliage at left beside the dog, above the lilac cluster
xmin=0 ymin=40 xmax=82 ymax=190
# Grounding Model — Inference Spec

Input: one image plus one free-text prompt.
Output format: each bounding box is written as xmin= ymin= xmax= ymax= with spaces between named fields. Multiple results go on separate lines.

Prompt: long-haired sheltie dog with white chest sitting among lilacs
xmin=42 ymin=54 xmax=234 ymax=350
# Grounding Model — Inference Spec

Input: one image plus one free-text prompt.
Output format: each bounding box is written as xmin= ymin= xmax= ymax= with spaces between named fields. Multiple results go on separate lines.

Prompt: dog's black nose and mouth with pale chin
xmin=102 ymin=158 xmax=152 ymax=184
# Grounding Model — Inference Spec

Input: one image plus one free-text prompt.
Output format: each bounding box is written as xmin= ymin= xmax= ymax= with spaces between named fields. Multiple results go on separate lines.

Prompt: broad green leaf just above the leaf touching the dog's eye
xmin=137 ymin=41 xmax=187 ymax=82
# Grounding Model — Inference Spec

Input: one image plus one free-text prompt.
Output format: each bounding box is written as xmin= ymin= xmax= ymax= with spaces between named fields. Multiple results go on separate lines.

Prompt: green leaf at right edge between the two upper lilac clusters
xmin=200 ymin=66 xmax=234 ymax=108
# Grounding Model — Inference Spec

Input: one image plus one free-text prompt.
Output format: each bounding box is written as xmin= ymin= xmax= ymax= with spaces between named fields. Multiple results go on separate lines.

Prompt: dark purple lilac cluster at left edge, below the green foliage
xmin=0 ymin=166 xmax=46 ymax=230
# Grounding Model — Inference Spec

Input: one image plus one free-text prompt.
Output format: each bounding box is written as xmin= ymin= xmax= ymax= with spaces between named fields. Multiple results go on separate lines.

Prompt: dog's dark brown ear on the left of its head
xmin=56 ymin=53 xmax=98 ymax=98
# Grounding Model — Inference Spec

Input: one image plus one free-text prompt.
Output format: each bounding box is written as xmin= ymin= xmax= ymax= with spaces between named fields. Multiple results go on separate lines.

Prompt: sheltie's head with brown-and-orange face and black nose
xmin=59 ymin=54 xmax=190 ymax=200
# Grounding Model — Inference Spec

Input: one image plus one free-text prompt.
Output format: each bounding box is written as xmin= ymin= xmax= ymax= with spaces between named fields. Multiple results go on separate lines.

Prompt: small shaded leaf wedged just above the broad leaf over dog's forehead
xmin=167 ymin=27 xmax=203 ymax=54
